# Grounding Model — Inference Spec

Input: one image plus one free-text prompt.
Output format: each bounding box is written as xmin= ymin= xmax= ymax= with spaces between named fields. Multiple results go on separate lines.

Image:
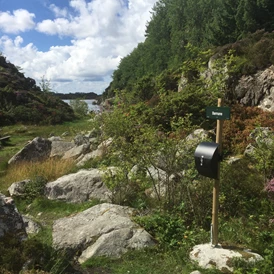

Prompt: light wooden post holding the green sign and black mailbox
xmin=211 ymin=98 xmax=223 ymax=246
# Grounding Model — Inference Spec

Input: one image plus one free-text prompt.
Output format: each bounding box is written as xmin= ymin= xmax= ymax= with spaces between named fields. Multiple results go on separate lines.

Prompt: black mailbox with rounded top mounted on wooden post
xmin=194 ymin=142 xmax=220 ymax=179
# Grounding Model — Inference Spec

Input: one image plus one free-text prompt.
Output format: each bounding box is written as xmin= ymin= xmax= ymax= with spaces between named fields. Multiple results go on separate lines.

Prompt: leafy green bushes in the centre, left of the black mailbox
xmin=99 ymin=95 xmax=202 ymax=207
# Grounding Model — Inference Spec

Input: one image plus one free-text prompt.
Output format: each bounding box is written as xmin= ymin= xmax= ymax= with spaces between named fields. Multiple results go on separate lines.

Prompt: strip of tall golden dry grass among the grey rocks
xmin=0 ymin=158 xmax=75 ymax=191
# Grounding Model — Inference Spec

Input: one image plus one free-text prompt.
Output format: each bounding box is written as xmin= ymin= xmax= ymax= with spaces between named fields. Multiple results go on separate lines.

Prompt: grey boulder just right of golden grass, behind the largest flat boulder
xmin=45 ymin=169 xmax=111 ymax=203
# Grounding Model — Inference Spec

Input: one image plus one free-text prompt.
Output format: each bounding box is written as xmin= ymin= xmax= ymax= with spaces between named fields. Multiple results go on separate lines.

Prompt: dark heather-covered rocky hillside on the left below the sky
xmin=0 ymin=56 xmax=74 ymax=126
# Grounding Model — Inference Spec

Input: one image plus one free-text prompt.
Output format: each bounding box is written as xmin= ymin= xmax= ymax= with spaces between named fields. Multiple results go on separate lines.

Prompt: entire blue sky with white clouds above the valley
xmin=0 ymin=0 xmax=157 ymax=94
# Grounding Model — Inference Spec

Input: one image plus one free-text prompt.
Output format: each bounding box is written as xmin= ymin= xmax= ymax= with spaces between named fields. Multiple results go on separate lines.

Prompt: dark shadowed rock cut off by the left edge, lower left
xmin=0 ymin=193 xmax=27 ymax=240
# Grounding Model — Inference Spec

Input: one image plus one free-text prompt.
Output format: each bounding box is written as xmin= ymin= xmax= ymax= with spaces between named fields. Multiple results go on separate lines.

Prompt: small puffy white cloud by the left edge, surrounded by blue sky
xmin=0 ymin=9 xmax=35 ymax=34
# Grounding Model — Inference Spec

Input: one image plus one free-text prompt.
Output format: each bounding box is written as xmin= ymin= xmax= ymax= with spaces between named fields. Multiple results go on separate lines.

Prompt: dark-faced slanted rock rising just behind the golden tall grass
xmin=8 ymin=137 xmax=51 ymax=164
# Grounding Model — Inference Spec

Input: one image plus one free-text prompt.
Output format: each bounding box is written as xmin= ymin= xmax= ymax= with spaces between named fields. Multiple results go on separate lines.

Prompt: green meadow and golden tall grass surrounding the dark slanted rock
xmin=0 ymin=119 xmax=96 ymax=191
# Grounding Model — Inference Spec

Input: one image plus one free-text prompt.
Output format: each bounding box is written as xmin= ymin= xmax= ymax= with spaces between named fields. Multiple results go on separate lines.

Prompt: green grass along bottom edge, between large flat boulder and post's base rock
xmin=82 ymin=247 xmax=221 ymax=274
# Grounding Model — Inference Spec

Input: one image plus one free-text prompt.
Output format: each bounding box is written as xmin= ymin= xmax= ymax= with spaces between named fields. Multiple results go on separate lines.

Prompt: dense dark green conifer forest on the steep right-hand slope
xmin=103 ymin=0 xmax=274 ymax=99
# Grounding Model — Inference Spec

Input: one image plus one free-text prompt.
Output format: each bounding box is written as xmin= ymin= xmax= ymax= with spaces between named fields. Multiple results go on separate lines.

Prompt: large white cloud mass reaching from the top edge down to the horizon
xmin=0 ymin=0 xmax=157 ymax=94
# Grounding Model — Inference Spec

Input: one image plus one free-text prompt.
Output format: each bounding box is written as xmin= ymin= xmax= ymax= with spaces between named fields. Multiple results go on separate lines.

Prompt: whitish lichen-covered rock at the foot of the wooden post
xmin=190 ymin=243 xmax=263 ymax=273
